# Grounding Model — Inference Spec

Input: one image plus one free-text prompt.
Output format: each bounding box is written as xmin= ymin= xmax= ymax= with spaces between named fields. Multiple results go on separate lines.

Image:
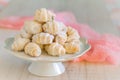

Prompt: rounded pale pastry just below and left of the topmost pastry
xmin=24 ymin=21 xmax=42 ymax=34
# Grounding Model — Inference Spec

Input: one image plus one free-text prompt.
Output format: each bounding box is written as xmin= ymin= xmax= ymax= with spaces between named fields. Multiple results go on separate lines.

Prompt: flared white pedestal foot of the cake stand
xmin=28 ymin=62 xmax=65 ymax=76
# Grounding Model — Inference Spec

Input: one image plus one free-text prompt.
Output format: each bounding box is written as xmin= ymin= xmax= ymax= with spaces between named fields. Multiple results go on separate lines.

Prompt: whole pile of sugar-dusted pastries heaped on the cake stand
xmin=11 ymin=8 xmax=80 ymax=57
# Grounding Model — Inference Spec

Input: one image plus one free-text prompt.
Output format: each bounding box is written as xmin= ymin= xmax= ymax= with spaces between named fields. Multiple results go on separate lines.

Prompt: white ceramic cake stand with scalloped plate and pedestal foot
xmin=4 ymin=38 xmax=91 ymax=76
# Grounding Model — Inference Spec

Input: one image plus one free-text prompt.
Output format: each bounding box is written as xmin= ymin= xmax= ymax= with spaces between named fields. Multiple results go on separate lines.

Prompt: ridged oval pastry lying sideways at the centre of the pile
xmin=32 ymin=32 xmax=54 ymax=44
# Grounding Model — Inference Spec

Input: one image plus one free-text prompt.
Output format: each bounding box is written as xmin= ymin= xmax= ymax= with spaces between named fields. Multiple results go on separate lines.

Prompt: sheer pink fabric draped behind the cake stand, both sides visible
xmin=0 ymin=12 xmax=120 ymax=64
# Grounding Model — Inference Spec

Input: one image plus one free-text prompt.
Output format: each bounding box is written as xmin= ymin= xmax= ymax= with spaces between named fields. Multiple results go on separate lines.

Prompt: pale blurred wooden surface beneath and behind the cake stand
xmin=0 ymin=0 xmax=120 ymax=80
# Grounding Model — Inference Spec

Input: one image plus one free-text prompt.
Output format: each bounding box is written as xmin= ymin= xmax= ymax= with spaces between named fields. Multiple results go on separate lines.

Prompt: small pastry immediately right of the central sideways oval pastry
xmin=55 ymin=33 xmax=67 ymax=45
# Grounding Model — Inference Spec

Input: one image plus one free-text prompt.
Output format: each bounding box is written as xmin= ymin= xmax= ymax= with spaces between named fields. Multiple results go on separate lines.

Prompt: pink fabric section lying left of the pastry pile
xmin=0 ymin=16 xmax=33 ymax=30
